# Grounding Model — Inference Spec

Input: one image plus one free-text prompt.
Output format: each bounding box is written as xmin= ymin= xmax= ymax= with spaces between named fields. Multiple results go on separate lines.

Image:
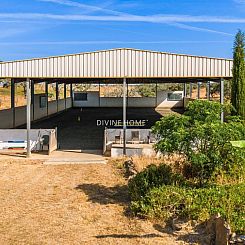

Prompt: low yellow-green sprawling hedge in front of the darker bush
xmin=131 ymin=184 xmax=245 ymax=233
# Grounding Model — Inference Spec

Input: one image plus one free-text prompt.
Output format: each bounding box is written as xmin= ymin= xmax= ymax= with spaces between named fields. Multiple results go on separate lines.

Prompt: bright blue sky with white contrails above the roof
xmin=0 ymin=0 xmax=245 ymax=61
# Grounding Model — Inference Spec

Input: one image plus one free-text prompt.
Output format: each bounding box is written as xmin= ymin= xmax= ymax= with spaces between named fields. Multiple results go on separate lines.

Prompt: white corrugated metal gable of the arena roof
xmin=0 ymin=48 xmax=233 ymax=79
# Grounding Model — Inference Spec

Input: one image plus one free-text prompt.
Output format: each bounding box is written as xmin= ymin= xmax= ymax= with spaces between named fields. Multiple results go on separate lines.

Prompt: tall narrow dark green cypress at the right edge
xmin=231 ymin=30 xmax=245 ymax=119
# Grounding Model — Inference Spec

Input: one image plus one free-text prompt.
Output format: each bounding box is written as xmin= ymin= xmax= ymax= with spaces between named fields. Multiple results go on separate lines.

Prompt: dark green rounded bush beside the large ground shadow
xmin=128 ymin=164 xmax=186 ymax=200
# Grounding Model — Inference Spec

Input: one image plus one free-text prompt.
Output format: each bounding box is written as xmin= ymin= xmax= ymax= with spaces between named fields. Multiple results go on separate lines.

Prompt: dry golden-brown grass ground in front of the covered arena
xmin=0 ymin=161 xmax=189 ymax=245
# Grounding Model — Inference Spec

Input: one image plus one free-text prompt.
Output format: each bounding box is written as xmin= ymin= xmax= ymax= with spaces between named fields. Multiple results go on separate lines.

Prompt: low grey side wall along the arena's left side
xmin=0 ymin=94 xmax=72 ymax=129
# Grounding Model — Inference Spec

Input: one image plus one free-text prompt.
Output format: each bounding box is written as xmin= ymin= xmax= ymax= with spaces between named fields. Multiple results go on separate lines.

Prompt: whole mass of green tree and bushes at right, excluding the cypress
xmin=129 ymin=100 xmax=245 ymax=233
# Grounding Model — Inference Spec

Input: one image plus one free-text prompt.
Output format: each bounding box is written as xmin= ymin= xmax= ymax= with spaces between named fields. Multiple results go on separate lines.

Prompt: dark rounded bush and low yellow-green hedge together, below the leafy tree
xmin=129 ymin=164 xmax=245 ymax=234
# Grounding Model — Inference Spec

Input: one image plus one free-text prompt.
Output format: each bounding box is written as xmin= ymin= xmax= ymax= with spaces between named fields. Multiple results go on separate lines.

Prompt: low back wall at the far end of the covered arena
xmin=73 ymin=91 xmax=183 ymax=108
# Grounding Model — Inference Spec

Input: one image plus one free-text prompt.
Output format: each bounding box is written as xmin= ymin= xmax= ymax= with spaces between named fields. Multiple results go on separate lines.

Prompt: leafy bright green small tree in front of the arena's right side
xmin=152 ymin=100 xmax=245 ymax=185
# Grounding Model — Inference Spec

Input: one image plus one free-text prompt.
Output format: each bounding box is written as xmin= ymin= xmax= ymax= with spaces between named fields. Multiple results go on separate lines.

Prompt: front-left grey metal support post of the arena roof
xmin=26 ymin=78 xmax=31 ymax=158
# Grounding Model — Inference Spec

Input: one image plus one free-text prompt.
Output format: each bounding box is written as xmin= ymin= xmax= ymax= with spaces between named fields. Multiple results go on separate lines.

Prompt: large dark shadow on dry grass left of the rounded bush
xmin=75 ymin=184 xmax=130 ymax=205
